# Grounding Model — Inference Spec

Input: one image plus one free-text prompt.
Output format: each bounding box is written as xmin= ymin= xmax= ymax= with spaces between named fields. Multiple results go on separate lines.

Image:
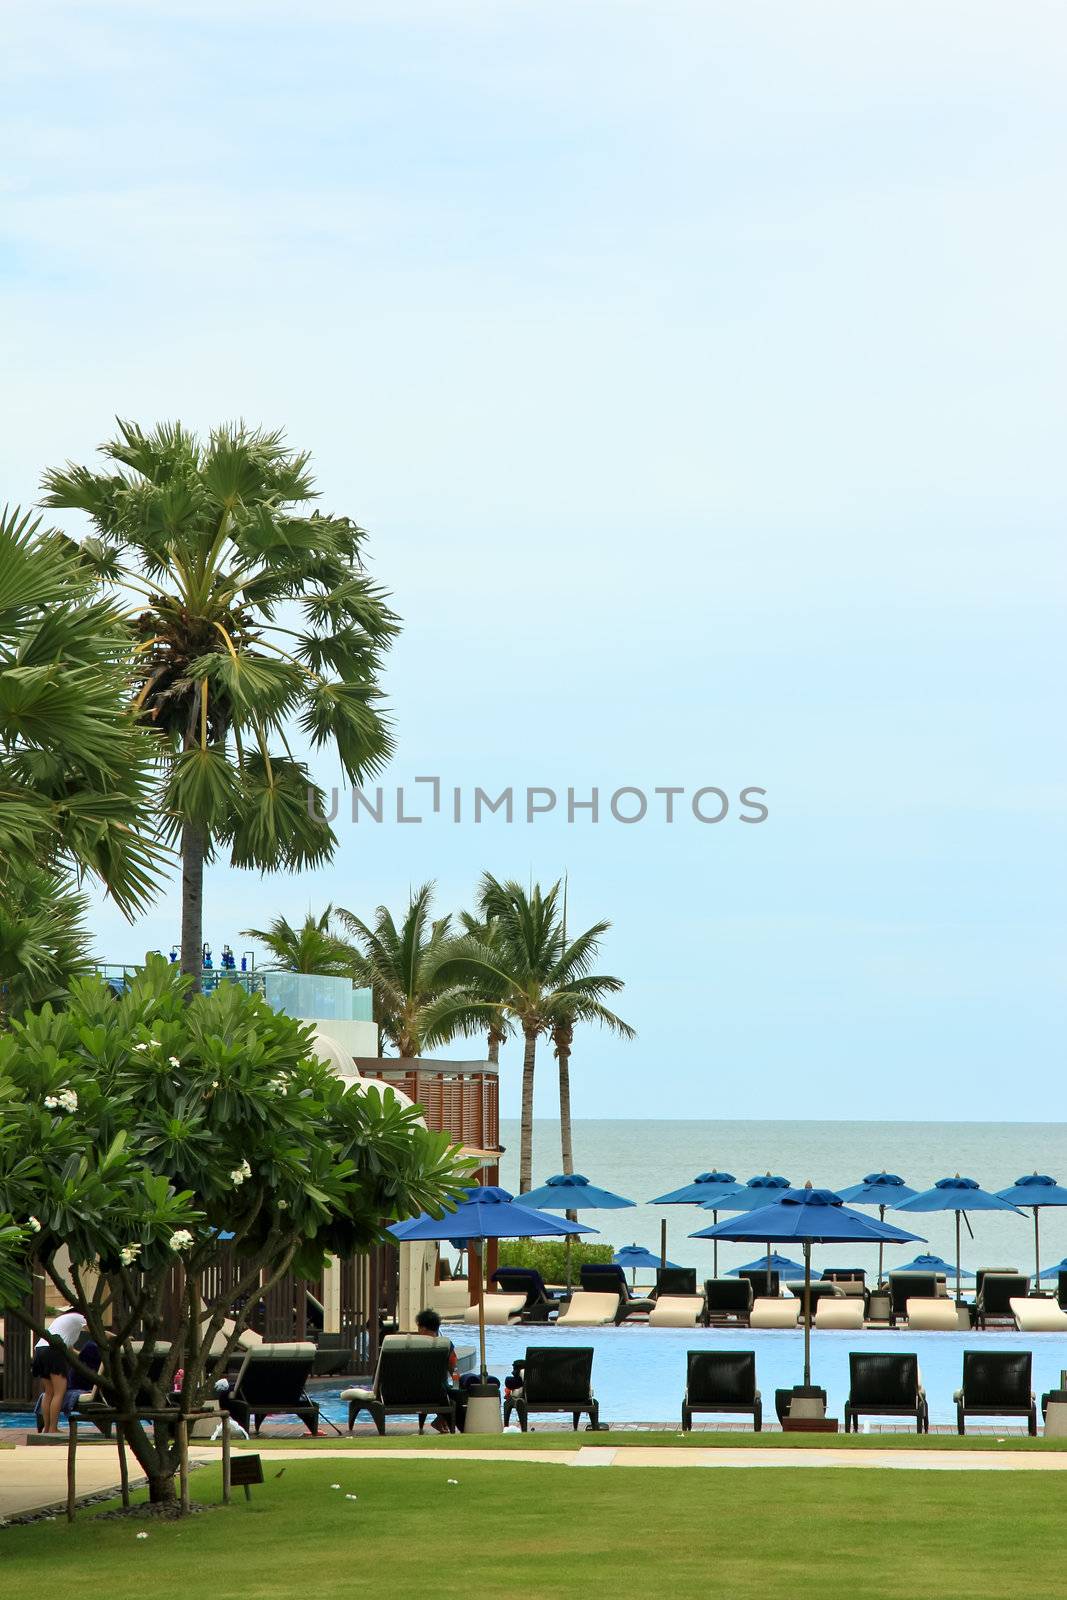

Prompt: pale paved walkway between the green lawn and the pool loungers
xmin=10 ymin=1445 xmax=1067 ymax=1520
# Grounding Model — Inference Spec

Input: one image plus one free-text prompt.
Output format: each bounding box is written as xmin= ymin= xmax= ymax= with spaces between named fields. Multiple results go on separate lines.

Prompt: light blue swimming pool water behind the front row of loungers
xmin=448 ymin=1323 xmax=1067 ymax=1426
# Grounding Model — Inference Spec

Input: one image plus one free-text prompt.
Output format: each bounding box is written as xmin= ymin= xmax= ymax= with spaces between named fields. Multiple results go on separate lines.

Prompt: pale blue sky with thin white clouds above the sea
xmin=0 ymin=0 xmax=1067 ymax=1120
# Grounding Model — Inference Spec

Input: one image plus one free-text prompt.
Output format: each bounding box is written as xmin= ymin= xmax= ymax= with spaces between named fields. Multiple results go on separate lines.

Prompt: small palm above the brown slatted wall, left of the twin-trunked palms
xmin=338 ymin=883 xmax=451 ymax=1059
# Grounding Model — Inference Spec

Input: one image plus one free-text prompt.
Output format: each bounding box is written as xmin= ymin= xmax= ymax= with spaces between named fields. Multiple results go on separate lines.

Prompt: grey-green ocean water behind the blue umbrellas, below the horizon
xmin=501 ymin=1118 xmax=1067 ymax=1282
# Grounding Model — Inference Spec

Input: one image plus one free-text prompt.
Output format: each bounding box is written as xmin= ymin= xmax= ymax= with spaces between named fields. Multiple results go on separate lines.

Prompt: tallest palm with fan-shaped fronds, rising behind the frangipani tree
xmin=45 ymin=421 xmax=397 ymax=982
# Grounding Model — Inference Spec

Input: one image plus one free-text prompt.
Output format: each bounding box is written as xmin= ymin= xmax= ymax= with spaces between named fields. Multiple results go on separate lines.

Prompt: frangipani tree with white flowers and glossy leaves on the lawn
xmin=0 ymin=958 xmax=464 ymax=1501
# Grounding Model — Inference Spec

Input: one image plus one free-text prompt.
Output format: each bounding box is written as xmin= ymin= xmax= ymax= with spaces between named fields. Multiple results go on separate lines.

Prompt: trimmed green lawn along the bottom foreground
xmin=0 ymin=1456 xmax=1067 ymax=1600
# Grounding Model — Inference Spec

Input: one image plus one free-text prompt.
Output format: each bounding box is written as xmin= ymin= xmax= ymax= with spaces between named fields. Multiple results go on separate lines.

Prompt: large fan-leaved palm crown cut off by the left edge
xmin=0 ymin=510 xmax=160 ymax=1011
